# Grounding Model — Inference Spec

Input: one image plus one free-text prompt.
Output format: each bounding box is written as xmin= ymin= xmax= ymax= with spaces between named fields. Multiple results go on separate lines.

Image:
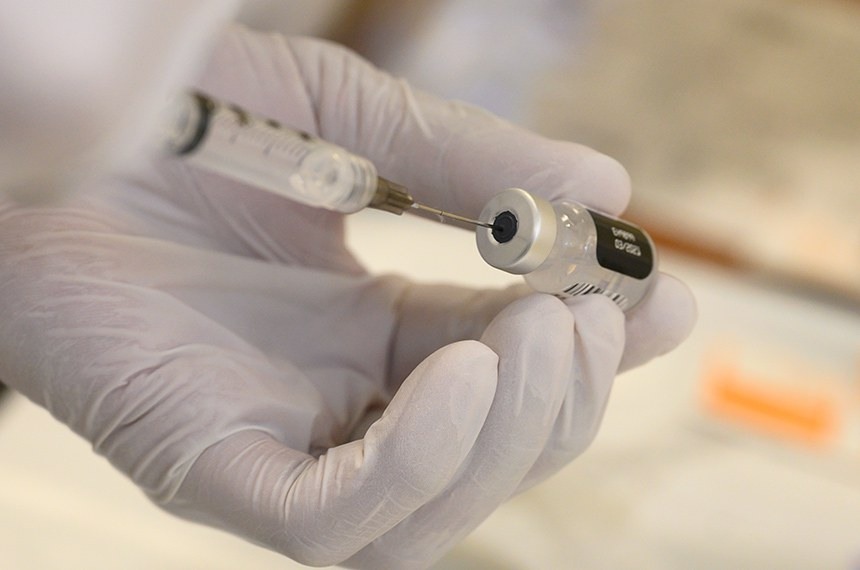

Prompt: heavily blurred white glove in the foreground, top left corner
xmin=0 ymin=0 xmax=236 ymax=202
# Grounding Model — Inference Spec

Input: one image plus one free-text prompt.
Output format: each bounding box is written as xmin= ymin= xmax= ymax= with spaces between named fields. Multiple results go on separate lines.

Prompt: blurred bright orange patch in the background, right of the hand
xmin=702 ymin=351 xmax=840 ymax=448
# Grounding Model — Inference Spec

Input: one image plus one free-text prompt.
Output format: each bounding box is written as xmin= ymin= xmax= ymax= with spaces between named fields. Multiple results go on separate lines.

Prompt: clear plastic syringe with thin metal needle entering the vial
xmin=163 ymin=93 xmax=492 ymax=228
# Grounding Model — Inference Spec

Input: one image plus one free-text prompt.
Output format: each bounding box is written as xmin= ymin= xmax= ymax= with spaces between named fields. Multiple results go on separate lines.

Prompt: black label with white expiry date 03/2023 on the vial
xmin=588 ymin=210 xmax=654 ymax=279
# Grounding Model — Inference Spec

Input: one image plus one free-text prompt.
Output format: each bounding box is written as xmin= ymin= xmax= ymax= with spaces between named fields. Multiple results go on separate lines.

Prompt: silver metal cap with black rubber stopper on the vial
xmin=475 ymin=188 xmax=556 ymax=275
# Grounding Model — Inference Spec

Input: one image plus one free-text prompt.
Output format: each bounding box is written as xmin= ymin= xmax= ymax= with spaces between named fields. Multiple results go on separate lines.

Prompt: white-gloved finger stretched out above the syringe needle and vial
xmin=288 ymin=39 xmax=630 ymax=216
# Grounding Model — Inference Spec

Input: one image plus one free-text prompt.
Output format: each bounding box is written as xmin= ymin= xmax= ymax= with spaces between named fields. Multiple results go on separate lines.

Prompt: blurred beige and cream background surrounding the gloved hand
xmin=0 ymin=0 xmax=860 ymax=570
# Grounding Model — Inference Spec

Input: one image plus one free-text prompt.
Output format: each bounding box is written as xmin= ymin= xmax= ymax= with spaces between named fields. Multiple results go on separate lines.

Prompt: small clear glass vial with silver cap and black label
xmin=476 ymin=188 xmax=657 ymax=311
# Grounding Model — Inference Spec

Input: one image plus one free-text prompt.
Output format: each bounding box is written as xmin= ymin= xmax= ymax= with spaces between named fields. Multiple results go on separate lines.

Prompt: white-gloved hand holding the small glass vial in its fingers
xmin=0 ymin=24 xmax=695 ymax=569
